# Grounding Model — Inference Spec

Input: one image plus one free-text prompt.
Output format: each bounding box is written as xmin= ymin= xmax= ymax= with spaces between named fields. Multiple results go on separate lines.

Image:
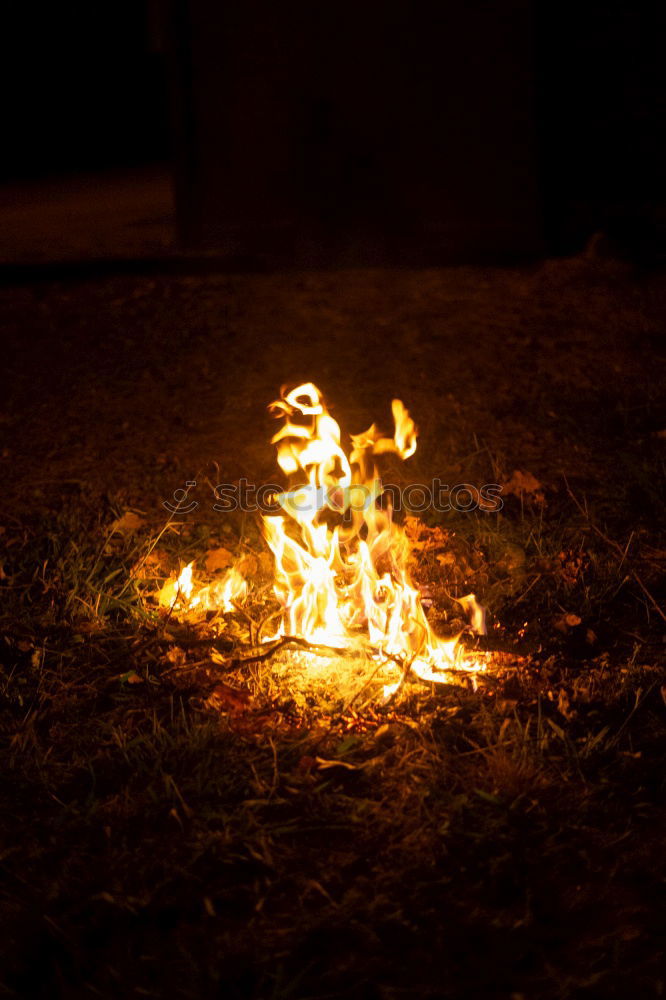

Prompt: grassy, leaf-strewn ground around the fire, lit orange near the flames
xmin=0 ymin=250 xmax=666 ymax=1000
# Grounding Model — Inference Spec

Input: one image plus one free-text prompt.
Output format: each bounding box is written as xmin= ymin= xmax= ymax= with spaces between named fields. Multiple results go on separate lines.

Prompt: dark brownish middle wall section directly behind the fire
xmin=171 ymin=0 xmax=542 ymax=263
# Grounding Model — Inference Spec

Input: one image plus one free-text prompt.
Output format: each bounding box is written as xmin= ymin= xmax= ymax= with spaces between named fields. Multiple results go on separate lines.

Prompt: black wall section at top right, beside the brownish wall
xmin=535 ymin=0 xmax=666 ymax=252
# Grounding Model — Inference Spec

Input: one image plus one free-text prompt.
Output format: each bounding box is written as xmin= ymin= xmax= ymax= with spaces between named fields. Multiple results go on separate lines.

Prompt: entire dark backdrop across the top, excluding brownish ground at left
xmin=0 ymin=0 xmax=666 ymax=263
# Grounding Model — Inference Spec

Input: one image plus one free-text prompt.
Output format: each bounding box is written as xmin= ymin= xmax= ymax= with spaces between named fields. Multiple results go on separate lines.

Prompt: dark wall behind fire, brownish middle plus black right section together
xmin=166 ymin=0 xmax=666 ymax=262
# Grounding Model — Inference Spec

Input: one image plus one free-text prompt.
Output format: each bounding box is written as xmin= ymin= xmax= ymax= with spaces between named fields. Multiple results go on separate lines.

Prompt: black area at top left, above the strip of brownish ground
xmin=0 ymin=0 xmax=170 ymax=180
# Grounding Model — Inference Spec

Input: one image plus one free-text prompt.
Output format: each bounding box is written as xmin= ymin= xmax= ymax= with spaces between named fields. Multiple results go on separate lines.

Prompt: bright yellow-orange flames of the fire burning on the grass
xmin=159 ymin=383 xmax=485 ymax=696
